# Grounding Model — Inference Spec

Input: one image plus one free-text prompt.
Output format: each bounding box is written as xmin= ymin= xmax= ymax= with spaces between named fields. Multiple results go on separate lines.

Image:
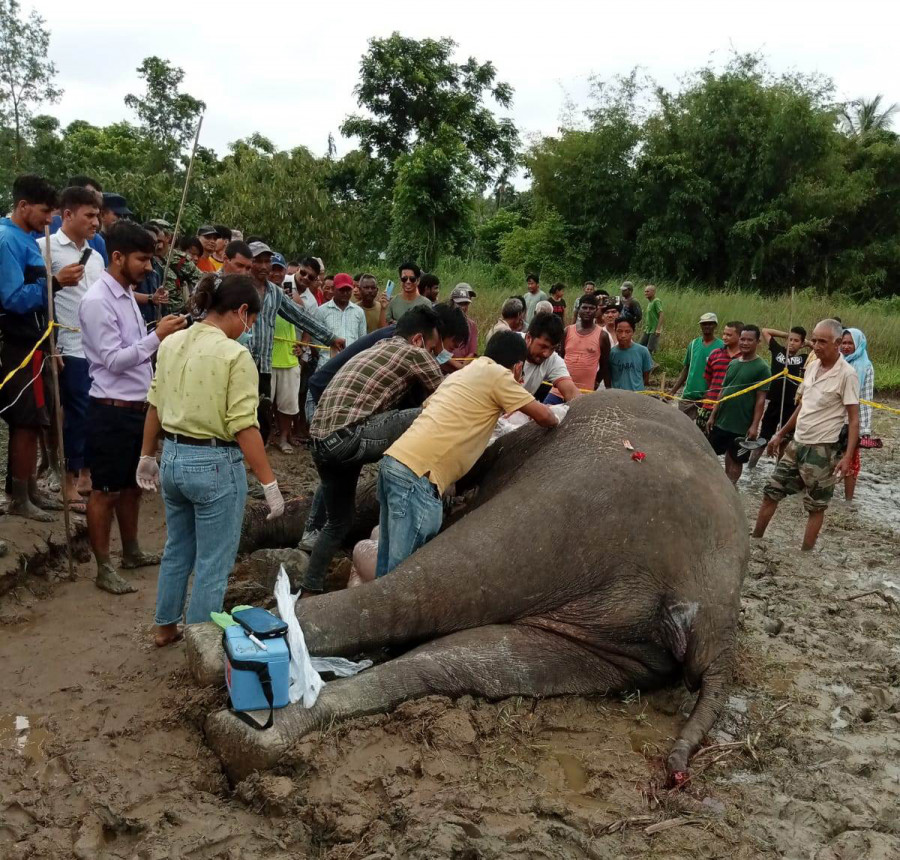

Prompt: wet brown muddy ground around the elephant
xmin=0 ymin=418 xmax=900 ymax=860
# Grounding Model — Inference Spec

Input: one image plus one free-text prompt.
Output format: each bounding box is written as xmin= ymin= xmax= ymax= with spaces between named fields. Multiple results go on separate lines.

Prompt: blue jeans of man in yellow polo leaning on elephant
xmin=375 ymin=456 xmax=444 ymax=576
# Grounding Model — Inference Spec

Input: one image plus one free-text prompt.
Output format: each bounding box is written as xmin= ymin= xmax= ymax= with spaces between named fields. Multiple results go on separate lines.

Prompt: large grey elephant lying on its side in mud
xmin=206 ymin=391 xmax=748 ymax=778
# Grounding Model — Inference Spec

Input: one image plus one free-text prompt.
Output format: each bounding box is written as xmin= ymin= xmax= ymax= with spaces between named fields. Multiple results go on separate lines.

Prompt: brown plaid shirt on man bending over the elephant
xmin=309 ymin=337 xmax=444 ymax=439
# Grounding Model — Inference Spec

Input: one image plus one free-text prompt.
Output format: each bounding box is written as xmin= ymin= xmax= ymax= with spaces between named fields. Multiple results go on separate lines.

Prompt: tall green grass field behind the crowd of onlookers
xmin=342 ymin=259 xmax=900 ymax=392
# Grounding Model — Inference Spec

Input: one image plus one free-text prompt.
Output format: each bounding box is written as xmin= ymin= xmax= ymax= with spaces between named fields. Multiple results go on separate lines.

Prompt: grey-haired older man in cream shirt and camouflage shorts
xmin=753 ymin=320 xmax=859 ymax=550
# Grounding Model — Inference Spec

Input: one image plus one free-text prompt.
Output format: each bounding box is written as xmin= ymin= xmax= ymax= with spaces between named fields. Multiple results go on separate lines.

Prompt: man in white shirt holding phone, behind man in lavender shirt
xmin=38 ymin=186 xmax=105 ymax=513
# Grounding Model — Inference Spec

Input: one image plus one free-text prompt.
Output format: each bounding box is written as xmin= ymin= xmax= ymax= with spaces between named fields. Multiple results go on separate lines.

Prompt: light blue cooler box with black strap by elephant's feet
xmin=225 ymin=624 xmax=290 ymax=711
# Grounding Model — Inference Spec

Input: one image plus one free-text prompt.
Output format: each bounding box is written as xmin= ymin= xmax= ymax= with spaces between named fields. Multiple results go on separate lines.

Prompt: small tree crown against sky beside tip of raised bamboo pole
xmin=125 ymin=57 xmax=206 ymax=152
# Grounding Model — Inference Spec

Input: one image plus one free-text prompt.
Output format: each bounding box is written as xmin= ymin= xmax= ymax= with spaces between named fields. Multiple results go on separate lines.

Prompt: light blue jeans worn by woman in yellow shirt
xmin=155 ymin=439 xmax=247 ymax=625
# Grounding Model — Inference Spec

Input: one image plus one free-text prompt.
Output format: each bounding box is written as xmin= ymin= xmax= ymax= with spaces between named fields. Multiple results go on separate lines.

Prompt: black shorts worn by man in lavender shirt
xmin=85 ymin=399 xmax=144 ymax=493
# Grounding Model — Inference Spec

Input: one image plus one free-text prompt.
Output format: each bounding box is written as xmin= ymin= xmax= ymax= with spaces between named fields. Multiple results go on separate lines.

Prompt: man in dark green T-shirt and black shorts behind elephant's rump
xmin=707 ymin=325 xmax=771 ymax=484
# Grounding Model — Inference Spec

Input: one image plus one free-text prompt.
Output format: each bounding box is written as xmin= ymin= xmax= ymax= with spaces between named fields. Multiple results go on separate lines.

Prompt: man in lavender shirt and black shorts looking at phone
xmin=78 ymin=221 xmax=186 ymax=594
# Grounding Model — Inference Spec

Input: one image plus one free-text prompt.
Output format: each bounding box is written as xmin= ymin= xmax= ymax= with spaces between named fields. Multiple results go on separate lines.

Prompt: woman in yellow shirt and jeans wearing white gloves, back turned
xmin=137 ymin=275 xmax=284 ymax=646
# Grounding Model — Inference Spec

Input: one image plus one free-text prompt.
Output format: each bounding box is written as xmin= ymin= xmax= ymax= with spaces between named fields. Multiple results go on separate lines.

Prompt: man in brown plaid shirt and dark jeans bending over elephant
xmin=303 ymin=307 xmax=446 ymax=594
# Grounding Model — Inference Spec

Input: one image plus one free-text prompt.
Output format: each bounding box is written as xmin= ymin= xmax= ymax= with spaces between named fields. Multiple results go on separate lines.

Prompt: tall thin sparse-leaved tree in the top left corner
xmin=0 ymin=0 xmax=62 ymax=167
